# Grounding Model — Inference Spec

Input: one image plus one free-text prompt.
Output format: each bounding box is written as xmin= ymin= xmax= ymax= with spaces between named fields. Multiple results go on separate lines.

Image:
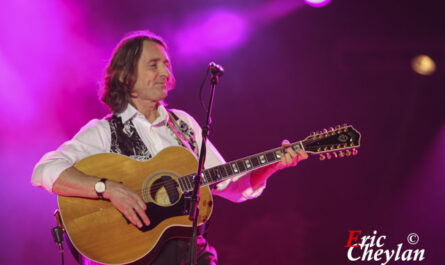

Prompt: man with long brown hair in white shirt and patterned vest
xmin=32 ymin=31 xmax=307 ymax=264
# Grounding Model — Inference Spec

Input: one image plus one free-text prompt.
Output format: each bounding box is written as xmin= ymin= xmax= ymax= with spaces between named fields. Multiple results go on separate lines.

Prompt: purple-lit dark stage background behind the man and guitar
xmin=0 ymin=0 xmax=445 ymax=265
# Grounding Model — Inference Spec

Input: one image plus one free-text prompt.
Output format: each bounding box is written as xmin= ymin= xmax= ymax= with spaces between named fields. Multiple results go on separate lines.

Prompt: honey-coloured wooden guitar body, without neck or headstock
xmin=58 ymin=147 xmax=213 ymax=264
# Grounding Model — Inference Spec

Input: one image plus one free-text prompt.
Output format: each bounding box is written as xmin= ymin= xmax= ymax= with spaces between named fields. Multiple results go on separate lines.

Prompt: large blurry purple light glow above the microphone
xmin=176 ymin=10 xmax=246 ymax=55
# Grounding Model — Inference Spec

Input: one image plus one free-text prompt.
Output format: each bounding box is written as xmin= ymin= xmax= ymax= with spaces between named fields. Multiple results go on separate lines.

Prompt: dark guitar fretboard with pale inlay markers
xmin=178 ymin=141 xmax=304 ymax=192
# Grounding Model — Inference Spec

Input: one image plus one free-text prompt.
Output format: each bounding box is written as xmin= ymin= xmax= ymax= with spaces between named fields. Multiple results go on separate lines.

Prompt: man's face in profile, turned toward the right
xmin=131 ymin=41 xmax=174 ymax=102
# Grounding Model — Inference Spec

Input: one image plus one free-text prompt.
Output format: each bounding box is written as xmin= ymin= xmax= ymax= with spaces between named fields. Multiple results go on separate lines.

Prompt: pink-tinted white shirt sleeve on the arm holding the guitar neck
xmin=172 ymin=110 xmax=266 ymax=202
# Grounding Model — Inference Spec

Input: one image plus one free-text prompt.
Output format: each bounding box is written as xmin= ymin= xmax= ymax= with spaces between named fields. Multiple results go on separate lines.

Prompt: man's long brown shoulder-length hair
xmin=101 ymin=30 xmax=167 ymax=113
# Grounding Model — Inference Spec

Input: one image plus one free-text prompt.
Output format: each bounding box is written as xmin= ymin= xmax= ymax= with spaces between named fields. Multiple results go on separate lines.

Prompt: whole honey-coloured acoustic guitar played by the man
xmin=58 ymin=125 xmax=361 ymax=264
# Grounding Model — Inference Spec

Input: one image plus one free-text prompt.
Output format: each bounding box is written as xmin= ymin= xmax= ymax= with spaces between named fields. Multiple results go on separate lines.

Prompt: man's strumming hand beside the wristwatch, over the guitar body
xmin=103 ymin=179 xmax=150 ymax=228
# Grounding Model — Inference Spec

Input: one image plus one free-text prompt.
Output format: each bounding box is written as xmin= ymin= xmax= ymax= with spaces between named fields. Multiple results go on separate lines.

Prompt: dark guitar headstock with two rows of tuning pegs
xmin=302 ymin=124 xmax=361 ymax=160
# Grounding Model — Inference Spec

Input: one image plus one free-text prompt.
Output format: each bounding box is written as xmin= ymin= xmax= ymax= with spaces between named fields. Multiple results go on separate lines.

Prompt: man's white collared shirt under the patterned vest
xmin=32 ymin=104 xmax=265 ymax=202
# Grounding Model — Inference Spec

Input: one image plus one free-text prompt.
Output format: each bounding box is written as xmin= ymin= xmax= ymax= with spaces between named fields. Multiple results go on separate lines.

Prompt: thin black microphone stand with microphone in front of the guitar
xmin=189 ymin=62 xmax=224 ymax=265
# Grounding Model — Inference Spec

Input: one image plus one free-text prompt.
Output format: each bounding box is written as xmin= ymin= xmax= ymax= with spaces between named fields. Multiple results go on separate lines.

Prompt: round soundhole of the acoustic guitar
xmin=150 ymin=176 xmax=180 ymax=206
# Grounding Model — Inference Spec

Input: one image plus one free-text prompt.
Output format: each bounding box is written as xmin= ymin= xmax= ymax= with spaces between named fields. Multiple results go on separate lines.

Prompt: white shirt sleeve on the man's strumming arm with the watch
xmin=31 ymin=119 xmax=111 ymax=193
